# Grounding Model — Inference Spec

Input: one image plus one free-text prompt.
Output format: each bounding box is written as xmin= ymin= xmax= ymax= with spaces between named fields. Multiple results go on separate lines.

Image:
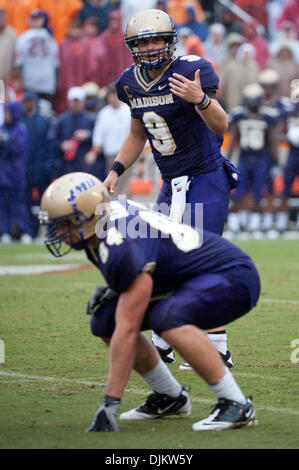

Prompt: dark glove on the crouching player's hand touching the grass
xmin=86 ymin=395 xmax=120 ymax=432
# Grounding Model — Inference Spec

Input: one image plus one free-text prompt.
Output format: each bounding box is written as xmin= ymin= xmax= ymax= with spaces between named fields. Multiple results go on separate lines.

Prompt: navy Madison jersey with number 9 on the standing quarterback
xmin=115 ymin=55 xmax=223 ymax=181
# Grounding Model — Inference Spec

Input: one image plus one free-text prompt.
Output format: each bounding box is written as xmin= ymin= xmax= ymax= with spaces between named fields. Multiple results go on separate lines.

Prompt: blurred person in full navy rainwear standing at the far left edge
xmin=0 ymin=101 xmax=32 ymax=243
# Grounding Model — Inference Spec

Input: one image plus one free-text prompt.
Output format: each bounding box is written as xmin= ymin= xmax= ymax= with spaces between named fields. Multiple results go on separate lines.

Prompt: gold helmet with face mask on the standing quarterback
xmin=125 ymin=9 xmax=178 ymax=69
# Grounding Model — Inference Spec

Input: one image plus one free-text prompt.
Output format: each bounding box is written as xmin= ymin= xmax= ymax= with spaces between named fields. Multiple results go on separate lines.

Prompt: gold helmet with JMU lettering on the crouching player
xmin=39 ymin=172 xmax=110 ymax=257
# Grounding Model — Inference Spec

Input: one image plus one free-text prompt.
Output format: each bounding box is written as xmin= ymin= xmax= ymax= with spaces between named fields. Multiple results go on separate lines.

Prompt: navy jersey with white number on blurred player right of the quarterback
xmin=229 ymin=106 xmax=278 ymax=158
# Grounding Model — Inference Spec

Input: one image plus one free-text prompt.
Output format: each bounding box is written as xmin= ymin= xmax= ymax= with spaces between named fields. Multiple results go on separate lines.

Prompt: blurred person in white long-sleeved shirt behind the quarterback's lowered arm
xmin=85 ymin=84 xmax=132 ymax=196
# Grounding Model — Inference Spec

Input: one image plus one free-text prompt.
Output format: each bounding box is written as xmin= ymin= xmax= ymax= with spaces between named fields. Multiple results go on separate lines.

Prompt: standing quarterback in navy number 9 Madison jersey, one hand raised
xmin=104 ymin=9 xmax=238 ymax=369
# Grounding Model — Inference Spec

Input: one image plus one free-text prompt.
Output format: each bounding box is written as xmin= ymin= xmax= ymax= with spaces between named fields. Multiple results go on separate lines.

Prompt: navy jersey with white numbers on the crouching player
xmin=87 ymin=201 xmax=257 ymax=295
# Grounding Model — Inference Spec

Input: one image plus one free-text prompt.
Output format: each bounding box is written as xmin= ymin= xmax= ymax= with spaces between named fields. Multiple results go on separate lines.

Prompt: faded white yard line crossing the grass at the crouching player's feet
xmin=0 ymin=370 xmax=299 ymax=416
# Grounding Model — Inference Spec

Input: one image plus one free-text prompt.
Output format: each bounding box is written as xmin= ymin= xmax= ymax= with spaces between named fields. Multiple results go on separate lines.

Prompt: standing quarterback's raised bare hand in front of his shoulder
xmin=168 ymin=69 xmax=204 ymax=104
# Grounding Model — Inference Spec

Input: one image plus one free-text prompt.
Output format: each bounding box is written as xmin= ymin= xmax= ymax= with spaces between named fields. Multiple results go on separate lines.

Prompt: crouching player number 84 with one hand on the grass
xmin=40 ymin=173 xmax=260 ymax=432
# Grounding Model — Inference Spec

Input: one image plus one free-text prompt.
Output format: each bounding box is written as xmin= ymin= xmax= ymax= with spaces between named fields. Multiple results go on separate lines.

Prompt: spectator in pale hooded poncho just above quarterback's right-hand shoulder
xmin=203 ymin=23 xmax=227 ymax=65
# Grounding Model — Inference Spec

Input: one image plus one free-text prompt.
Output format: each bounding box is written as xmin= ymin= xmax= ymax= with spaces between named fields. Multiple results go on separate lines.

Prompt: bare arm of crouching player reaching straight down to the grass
xmin=106 ymin=273 xmax=153 ymax=398
